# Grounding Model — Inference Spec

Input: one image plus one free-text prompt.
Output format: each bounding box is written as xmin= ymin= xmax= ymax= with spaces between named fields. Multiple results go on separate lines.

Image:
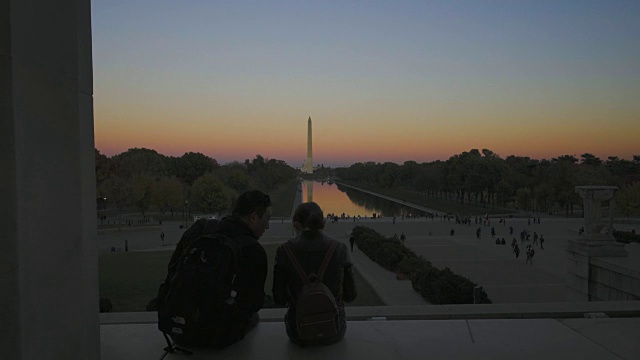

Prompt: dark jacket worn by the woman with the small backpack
xmin=273 ymin=230 xmax=357 ymax=343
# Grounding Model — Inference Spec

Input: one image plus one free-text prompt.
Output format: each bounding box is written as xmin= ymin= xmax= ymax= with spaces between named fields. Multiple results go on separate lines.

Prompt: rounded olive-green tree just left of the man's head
xmin=189 ymin=174 xmax=231 ymax=213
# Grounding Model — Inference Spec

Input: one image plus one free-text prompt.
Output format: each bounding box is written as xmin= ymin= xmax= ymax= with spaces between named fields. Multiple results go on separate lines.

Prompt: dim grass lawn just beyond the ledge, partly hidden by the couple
xmin=99 ymin=244 xmax=384 ymax=312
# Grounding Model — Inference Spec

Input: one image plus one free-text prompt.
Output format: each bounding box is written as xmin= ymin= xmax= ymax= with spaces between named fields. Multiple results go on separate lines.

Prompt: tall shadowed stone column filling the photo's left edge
xmin=0 ymin=0 xmax=100 ymax=360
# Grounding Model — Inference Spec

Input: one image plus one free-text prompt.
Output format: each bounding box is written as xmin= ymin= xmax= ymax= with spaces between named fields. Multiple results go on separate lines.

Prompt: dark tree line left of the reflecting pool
xmin=95 ymin=148 xmax=297 ymax=217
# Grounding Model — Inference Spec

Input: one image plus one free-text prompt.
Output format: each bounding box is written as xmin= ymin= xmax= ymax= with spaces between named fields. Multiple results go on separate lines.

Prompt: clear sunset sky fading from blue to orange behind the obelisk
xmin=92 ymin=0 xmax=640 ymax=167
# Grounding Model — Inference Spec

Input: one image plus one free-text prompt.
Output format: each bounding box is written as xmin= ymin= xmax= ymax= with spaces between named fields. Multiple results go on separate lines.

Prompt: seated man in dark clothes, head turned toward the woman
xmin=159 ymin=190 xmax=271 ymax=348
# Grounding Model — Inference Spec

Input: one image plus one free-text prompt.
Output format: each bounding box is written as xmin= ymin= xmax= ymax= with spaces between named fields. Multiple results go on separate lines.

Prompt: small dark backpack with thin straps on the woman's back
xmin=283 ymin=240 xmax=339 ymax=344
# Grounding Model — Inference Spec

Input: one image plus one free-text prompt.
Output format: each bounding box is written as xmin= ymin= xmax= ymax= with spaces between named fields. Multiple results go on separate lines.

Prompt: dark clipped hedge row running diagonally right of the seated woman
xmin=353 ymin=226 xmax=491 ymax=304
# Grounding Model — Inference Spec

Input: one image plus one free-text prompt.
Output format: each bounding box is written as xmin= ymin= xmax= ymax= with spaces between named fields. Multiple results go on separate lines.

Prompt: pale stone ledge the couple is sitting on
xmin=101 ymin=318 xmax=640 ymax=360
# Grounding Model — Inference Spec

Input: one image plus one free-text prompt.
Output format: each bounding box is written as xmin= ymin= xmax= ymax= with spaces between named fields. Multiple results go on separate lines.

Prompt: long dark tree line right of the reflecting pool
xmin=335 ymin=149 xmax=640 ymax=216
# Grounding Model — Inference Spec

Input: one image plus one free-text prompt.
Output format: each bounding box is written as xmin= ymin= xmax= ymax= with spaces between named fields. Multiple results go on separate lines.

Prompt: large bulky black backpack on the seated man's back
xmin=157 ymin=219 xmax=242 ymax=353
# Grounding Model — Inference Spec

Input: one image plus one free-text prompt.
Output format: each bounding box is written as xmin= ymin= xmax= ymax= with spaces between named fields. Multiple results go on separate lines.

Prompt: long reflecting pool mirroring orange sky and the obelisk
xmin=302 ymin=180 xmax=425 ymax=217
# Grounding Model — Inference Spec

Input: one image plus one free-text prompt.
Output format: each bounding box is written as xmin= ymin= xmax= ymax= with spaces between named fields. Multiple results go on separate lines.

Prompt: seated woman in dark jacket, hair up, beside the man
xmin=273 ymin=202 xmax=357 ymax=346
